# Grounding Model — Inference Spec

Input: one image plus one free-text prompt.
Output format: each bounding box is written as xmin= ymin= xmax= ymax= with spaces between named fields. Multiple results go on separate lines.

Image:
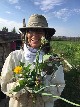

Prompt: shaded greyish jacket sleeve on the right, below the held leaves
xmin=49 ymin=65 xmax=65 ymax=97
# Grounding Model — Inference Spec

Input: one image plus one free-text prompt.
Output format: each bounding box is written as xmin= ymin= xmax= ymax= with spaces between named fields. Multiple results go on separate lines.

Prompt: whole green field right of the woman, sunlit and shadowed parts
xmin=51 ymin=41 xmax=80 ymax=107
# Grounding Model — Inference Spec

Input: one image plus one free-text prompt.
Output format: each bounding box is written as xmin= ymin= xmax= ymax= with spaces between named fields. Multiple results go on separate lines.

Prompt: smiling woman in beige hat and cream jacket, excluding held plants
xmin=1 ymin=14 xmax=65 ymax=107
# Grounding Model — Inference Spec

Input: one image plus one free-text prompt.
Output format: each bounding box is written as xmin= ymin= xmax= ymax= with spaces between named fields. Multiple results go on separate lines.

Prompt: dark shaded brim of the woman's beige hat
xmin=19 ymin=27 xmax=56 ymax=36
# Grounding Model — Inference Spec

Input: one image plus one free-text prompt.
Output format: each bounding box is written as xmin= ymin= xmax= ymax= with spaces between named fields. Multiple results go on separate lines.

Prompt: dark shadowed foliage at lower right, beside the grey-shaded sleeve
xmin=55 ymin=67 xmax=80 ymax=107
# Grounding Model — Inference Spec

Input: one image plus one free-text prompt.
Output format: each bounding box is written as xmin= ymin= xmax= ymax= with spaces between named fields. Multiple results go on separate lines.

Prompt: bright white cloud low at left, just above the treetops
xmin=0 ymin=18 xmax=22 ymax=32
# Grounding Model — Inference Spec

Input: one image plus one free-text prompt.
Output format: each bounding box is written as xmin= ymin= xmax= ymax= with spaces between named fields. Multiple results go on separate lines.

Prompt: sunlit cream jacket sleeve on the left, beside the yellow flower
xmin=1 ymin=52 xmax=21 ymax=97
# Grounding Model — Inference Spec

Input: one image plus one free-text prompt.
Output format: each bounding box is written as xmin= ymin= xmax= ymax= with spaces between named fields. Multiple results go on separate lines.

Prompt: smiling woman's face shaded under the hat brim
xmin=27 ymin=29 xmax=45 ymax=48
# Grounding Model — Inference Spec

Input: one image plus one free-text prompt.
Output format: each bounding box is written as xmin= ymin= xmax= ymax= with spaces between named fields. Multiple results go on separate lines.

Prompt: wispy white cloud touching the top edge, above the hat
xmin=34 ymin=0 xmax=63 ymax=11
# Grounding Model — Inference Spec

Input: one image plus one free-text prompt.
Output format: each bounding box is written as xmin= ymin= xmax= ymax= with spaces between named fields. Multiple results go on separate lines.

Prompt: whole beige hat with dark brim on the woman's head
xmin=19 ymin=14 xmax=55 ymax=36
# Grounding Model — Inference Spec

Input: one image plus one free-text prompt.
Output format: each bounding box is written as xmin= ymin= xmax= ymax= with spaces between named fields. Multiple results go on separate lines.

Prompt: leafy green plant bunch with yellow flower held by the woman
xmin=13 ymin=51 xmax=60 ymax=93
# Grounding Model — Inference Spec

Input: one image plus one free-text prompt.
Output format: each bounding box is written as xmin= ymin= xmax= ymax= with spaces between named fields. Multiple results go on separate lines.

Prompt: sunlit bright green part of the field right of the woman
xmin=51 ymin=41 xmax=80 ymax=66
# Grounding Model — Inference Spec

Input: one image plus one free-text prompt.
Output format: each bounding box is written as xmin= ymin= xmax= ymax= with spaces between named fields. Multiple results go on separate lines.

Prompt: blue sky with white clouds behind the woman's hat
xmin=0 ymin=0 xmax=80 ymax=37
